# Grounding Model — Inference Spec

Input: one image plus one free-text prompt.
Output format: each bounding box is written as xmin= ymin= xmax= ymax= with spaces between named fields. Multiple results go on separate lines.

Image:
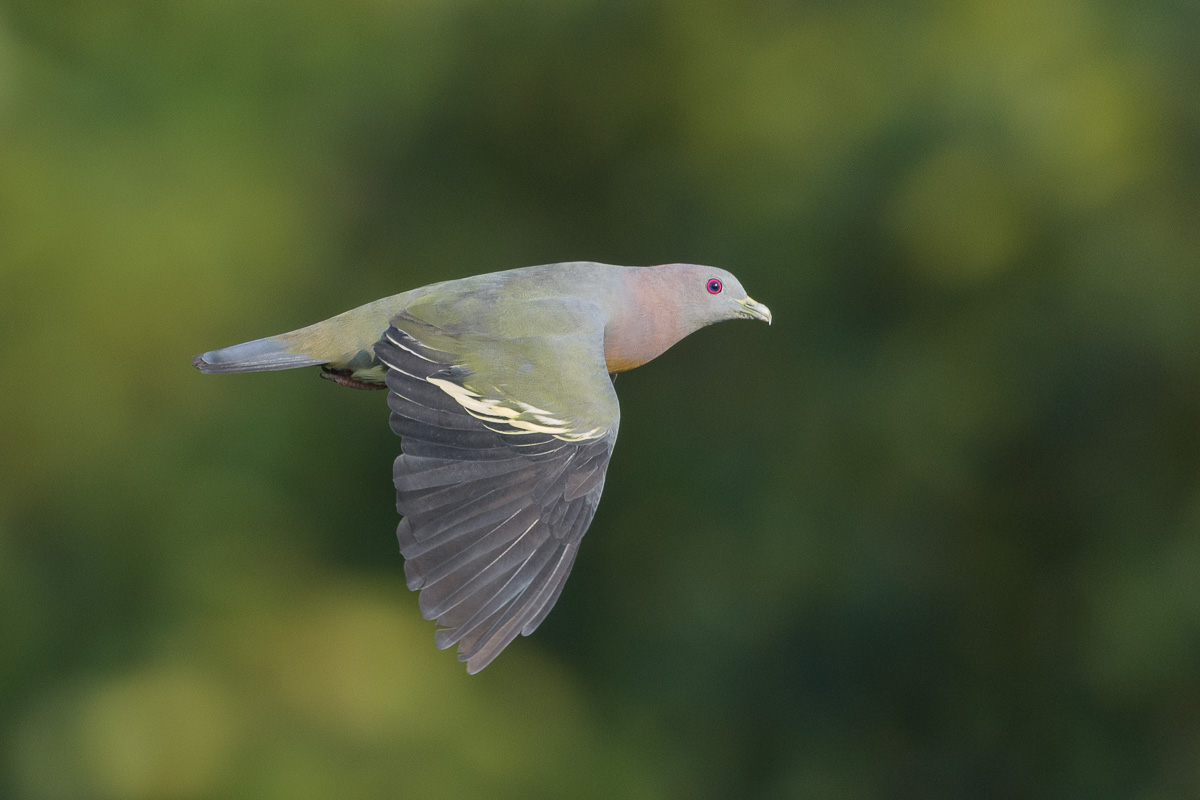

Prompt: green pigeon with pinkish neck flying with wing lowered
xmin=193 ymin=261 xmax=770 ymax=673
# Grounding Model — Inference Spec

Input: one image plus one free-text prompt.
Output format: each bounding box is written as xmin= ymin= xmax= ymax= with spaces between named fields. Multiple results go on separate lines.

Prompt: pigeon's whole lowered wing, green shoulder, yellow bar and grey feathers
xmin=376 ymin=313 xmax=619 ymax=673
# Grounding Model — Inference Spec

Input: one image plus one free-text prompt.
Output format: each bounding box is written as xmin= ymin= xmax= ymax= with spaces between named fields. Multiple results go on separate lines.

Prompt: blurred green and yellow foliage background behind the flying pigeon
xmin=0 ymin=0 xmax=1200 ymax=800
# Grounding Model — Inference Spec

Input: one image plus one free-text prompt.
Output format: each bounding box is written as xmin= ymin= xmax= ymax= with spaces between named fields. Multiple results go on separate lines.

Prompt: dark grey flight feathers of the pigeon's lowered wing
xmin=376 ymin=325 xmax=616 ymax=673
